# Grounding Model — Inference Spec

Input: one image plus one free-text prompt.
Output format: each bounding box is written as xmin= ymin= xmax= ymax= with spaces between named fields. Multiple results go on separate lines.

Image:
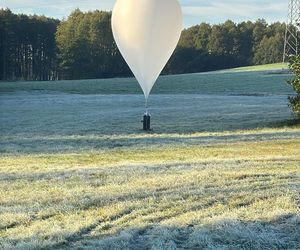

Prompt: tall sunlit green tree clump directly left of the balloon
xmin=56 ymin=9 xmax=130 ymax=79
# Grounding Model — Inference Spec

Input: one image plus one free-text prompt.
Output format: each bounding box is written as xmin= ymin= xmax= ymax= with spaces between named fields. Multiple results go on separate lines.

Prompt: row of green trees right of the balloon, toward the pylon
xmin=167 ymin=19 xmax=286 ymax=73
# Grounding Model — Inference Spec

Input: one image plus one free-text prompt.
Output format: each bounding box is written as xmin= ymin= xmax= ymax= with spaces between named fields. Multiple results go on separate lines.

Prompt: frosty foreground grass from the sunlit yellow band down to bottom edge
xmin=0 ymin=127 xmax=300 ymax=249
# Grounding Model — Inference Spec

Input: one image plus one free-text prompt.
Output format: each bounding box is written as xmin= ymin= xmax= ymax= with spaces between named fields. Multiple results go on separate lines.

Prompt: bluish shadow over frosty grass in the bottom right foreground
xmin=52 ymin=214 xmax=300 ymax=250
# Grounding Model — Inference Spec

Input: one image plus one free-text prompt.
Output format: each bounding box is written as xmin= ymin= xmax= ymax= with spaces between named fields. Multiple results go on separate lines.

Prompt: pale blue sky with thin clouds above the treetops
xmin=0 ymin=0 xmax=288 ymax=27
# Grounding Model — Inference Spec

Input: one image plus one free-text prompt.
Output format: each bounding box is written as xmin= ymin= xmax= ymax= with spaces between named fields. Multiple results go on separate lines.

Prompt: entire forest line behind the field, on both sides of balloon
xmin=0 ymin=9 xmax=285 ymax=80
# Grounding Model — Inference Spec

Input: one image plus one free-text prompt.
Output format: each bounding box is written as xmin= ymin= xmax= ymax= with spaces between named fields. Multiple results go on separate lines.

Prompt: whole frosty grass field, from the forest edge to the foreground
xmin=0 ymin=65 xmax=300 ymax=250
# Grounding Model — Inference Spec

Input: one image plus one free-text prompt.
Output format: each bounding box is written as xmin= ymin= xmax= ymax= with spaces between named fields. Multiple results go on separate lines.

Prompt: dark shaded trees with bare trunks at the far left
xmin=0 ymin=9 xmax=59 ymax=80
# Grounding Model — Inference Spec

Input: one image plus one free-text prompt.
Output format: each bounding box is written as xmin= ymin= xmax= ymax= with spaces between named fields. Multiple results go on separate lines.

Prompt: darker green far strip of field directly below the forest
xmin=0 ymin=64 xmax=292 ymax=95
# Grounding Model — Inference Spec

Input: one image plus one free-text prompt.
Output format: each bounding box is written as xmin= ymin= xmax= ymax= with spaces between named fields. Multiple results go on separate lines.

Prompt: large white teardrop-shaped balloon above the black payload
xmin=112 ymin=0 xmax=183 ymax=100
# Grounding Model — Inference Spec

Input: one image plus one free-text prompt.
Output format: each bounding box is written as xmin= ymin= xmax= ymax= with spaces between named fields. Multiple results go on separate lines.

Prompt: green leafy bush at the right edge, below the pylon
xmin=288 ymin=56 xmax=300 ymax=116
